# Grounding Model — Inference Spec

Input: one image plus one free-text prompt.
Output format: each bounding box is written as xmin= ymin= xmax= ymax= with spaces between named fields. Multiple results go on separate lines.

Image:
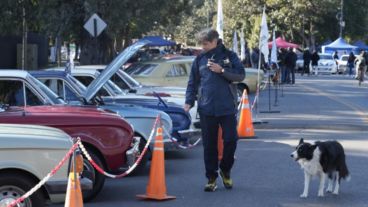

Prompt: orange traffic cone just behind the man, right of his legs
xmin=238 ymin=90 xmax=254 ymax=139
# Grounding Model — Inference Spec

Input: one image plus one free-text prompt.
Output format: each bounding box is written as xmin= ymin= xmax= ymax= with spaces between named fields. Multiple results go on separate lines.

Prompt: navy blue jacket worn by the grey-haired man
xmin=185 ymin=41 xmax=245 ymax=116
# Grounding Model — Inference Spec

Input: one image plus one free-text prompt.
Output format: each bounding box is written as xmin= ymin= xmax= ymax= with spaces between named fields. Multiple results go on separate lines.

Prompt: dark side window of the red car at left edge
xmin=0 ymin=80 xmax=24 ymax=106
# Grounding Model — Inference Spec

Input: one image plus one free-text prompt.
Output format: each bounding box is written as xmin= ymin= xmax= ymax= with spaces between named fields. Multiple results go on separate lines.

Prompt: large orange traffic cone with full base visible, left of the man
xmin=137 ymin=127 xmax=176 ymax=200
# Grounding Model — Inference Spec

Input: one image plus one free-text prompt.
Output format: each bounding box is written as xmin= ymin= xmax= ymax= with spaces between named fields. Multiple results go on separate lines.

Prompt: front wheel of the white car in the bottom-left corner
xmin=0 ymin=173 xmax=46 ymax=207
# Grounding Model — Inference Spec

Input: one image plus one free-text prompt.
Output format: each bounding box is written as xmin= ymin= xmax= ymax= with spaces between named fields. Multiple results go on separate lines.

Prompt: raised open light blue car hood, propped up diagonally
xmin=83 ymin=41 xmax=149 ymax=101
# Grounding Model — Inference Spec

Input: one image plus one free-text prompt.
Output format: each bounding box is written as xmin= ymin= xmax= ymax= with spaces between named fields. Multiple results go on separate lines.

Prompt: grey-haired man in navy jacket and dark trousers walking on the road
xmin=184 ymin=29 xmax=245 ymax=192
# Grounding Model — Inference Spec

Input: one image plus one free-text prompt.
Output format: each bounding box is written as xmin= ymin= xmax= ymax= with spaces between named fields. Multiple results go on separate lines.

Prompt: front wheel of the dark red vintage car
xmin=81 ymin=150 xmax=105 ymax=202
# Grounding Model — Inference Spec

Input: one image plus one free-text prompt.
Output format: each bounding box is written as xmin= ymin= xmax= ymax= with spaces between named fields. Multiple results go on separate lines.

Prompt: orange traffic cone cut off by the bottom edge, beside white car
xmin=65 ymin=171 xmax=83 ymax=207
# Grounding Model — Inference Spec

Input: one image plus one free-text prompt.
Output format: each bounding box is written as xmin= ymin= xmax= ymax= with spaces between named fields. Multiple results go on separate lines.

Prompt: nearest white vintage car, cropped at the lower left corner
xmin=0 ymin=124 xmax=92 ymax=207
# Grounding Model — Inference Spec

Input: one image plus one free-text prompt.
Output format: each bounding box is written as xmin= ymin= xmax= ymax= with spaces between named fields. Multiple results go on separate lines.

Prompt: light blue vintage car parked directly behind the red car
xmin=30 ymin=70 xmax=176 ymax=156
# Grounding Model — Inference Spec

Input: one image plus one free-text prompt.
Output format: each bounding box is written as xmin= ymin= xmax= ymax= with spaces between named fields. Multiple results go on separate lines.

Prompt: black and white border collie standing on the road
xmin=291 ymin=138 xmax=350 ymax=198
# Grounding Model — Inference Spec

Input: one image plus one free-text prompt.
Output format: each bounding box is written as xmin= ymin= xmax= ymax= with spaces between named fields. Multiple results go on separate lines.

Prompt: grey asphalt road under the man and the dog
xmin=53 ymin=73 xmax=368 ymax=207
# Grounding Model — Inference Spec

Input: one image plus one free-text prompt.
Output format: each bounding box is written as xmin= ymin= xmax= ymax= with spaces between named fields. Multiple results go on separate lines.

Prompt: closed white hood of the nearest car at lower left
xmin=0 ymin=124 xmax=72 ymax=150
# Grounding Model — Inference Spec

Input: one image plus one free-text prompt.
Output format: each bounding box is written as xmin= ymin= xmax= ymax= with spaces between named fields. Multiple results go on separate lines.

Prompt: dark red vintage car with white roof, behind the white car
xmin=0 ymin=70 xmax=139 ymax=201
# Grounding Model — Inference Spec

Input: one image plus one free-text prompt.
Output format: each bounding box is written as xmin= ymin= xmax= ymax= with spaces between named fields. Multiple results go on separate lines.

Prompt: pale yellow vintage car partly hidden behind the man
xmin=124 ymin=56 xmax=264 ymax=93
